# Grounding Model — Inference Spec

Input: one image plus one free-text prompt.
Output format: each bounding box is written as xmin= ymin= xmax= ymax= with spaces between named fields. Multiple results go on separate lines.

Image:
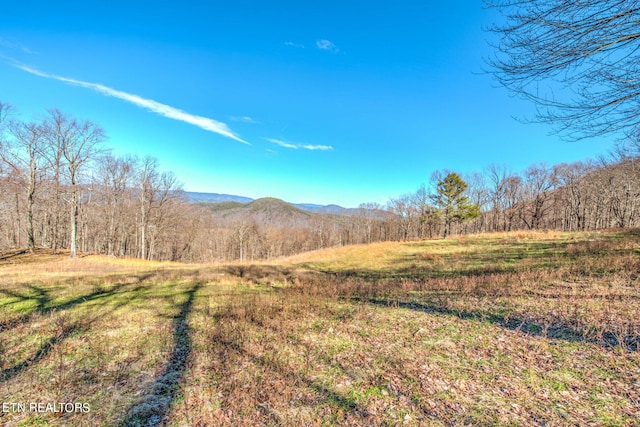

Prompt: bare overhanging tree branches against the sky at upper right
xmin=484 ymin=0 xmax=640 ymax=144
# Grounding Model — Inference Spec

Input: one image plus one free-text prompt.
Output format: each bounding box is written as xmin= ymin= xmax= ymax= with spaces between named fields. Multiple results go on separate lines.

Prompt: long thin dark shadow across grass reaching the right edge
xmin=360 ymin=297 xmax=640 ymax=351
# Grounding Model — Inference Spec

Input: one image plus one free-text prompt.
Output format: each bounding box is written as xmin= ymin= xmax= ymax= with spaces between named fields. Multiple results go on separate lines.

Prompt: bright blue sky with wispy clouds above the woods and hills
xmin=0 ymin=0 xmax=612 ymax=207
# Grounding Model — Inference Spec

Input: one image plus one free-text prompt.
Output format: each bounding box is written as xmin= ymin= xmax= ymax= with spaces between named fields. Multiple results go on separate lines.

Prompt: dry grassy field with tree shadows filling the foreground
xmin=0 ymin=230 xmax=640 ymax=426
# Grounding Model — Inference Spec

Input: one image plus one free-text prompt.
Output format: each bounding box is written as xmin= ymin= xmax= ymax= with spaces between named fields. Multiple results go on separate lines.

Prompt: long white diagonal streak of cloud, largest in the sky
xmin=14 ymin=64 xmax=251 ymax=145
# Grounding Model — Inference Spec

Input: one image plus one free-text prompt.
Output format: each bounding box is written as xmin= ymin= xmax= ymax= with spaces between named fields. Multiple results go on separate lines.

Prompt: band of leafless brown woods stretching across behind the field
xmin=0 ymin=104 xmax=640 ymax=262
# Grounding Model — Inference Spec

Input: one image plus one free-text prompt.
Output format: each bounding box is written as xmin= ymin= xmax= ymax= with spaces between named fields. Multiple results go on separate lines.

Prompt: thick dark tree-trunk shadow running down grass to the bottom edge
xmin=120 ymin=283 xmax=202 ymax=427
